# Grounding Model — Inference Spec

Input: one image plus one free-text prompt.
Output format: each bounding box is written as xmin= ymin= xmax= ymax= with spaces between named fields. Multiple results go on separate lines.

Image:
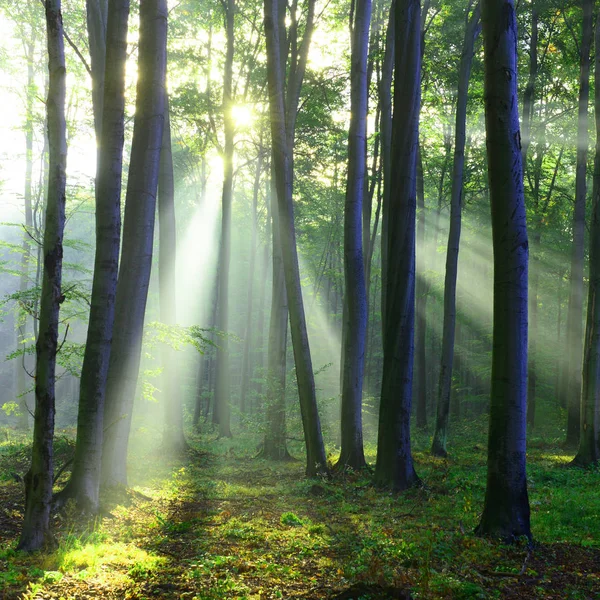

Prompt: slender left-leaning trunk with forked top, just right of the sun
xmin=265 ymin=0 xmax=327 ymax=476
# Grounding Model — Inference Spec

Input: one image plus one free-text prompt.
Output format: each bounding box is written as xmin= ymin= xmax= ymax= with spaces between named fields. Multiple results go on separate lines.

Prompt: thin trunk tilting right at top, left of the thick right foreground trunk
xmin=431 ymin=3 xmax=480 ymax=456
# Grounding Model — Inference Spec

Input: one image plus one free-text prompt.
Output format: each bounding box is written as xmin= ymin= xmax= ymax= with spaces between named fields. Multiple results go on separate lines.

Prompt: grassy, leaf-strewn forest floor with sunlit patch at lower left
xmin=0 ymin=423 xmax=600 ymax=600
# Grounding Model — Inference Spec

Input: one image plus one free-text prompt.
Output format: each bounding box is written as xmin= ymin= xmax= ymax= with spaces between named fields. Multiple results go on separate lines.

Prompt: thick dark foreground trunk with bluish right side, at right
xmin=476 ymin=0 xmax=531 ymax=540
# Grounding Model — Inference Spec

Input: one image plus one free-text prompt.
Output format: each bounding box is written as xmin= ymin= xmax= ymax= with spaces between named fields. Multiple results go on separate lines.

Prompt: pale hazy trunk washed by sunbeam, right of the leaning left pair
xmin=158 ymin=96 xmax=187 ymax=454
